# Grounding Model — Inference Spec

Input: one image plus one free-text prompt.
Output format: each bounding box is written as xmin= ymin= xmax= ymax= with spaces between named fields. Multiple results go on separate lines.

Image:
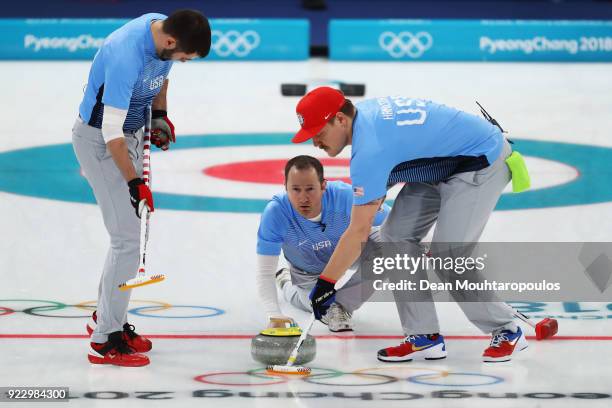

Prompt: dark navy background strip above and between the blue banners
xmin=0 ymin=0 xmax=612 ymax=46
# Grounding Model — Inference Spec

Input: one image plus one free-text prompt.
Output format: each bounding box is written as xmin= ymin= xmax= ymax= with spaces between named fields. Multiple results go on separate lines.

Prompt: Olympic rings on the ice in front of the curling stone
xmin=194 ymin=366 xmax=504 ymax=387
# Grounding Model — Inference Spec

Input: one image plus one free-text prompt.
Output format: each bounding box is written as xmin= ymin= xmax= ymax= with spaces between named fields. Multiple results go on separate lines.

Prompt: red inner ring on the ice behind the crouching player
xmin=202 ymin=158 xmax=351 ymax=184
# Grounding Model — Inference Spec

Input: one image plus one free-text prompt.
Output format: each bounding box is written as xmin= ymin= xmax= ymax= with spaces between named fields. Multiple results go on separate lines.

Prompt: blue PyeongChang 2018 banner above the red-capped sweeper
xmin=329 ymin=20 xmax=612 ymax=62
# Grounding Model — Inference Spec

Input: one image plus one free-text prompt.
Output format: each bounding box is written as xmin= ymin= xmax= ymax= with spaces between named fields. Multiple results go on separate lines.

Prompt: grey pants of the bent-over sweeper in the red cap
xmin=381 ymin=141 xmax=516 ymax=334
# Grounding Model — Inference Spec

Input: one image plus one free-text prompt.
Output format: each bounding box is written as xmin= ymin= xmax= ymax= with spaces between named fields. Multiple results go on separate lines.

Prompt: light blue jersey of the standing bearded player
xmin=79 ymin=13 xmax=172 ymax=132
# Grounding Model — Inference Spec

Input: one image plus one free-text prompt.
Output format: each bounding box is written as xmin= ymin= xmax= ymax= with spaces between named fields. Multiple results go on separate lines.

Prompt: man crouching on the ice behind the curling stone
xmin=257 ymin=156 xmax=389 ymax=332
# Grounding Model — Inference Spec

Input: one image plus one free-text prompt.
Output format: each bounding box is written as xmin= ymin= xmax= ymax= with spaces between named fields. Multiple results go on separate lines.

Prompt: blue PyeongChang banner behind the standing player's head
xmin=0 ymin=19 xmax=309 ymax=60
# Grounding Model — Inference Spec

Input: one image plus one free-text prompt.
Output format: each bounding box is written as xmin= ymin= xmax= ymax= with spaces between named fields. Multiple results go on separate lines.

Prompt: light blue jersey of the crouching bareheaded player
xmin=257 ymin=181 xmax=389 ymax=274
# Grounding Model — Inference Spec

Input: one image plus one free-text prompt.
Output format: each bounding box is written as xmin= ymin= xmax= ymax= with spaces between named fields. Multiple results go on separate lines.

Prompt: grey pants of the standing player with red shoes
xmin=72 ymin=118 xmax=143 ymax=343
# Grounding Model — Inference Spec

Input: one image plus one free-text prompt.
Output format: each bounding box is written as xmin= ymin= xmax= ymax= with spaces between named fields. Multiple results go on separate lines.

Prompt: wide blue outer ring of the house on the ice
xmin=0 ymin=133 xmax=612 ymax=213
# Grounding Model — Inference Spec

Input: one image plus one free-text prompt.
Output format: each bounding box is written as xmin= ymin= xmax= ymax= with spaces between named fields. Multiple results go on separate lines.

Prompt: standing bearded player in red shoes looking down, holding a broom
xmin=72 ymin=10 xmax=211 ymax=367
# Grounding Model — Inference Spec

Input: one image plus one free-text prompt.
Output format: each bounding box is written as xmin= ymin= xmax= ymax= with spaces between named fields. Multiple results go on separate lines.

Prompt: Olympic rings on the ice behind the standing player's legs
xmin=0 ymin=299 xmax=225 ymax=319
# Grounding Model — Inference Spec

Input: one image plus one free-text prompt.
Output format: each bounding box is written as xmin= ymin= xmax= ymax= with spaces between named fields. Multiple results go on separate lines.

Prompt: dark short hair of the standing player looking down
xmin=162 ymin=10 xmax=211 ymax=58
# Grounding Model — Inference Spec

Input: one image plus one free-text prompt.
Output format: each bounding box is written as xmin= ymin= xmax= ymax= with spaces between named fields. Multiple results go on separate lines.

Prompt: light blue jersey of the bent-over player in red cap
xmin=351 ymin=96 xmax=503 ymax=205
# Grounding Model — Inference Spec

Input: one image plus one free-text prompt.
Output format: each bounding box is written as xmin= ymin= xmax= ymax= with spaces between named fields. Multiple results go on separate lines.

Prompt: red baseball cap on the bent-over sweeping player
xmin=291 ymin=86 xmax=344 ymax=143
